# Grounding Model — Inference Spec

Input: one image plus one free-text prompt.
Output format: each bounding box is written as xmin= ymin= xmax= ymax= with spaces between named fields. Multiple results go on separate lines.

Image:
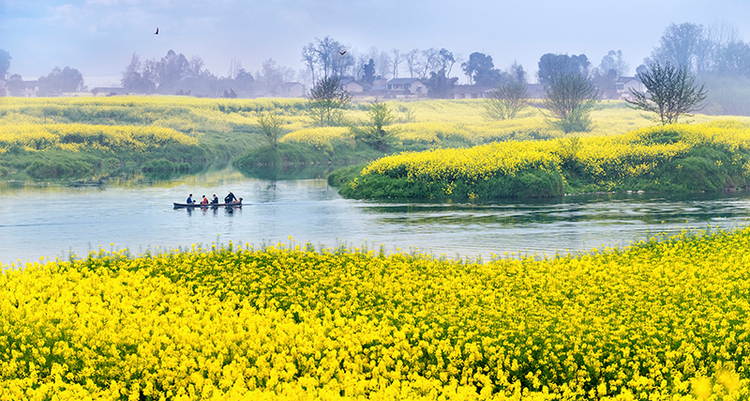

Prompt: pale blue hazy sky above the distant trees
xmin=0 ymin=0 xmax=750 ymax=87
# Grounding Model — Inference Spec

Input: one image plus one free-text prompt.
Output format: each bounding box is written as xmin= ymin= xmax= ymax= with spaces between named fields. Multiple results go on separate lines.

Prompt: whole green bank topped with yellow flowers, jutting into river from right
xmin=332 ymin=120 xmax=750 ymax=199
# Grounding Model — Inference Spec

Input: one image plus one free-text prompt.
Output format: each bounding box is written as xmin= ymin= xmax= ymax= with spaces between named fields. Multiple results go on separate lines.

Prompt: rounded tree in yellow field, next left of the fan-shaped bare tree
xmin=544 ymin=72 xmax=598 ymax=133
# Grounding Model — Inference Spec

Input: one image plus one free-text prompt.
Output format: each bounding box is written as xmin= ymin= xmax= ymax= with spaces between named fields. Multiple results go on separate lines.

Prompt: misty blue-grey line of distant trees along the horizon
xmin=0 ymin=19 xmax=750 ymax=115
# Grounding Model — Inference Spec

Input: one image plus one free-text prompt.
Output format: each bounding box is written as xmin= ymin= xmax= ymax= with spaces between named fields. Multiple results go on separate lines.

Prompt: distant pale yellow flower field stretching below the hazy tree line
xmin=0 ymin=96 xmax=750 ymax=155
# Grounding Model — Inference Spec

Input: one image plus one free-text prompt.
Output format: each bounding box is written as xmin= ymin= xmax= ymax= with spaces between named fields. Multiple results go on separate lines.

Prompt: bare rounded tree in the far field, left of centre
xmin=308 ymin=76 xmax=352 ymax=127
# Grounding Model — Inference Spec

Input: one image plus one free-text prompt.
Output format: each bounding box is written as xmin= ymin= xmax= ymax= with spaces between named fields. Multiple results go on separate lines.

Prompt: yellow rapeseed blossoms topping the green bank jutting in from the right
xmin=352 ymin=120 xmax=750 ymax=191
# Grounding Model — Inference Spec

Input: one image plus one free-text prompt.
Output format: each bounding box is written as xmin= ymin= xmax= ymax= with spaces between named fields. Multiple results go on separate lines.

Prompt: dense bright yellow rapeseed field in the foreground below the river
xmin=0 ymin=228 xmax=750 ymax=400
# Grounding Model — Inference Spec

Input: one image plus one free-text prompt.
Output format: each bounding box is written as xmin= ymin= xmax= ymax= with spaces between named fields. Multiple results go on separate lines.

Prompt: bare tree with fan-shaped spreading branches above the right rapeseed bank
xmin=626 ymin=62 xmax=706 ymax=125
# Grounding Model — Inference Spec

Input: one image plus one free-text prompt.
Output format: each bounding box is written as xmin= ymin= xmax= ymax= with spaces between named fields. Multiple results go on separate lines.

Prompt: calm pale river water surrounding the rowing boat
xmin=0 ymin=173 xmax=750 ymax=265
